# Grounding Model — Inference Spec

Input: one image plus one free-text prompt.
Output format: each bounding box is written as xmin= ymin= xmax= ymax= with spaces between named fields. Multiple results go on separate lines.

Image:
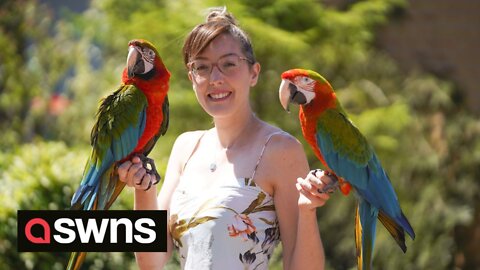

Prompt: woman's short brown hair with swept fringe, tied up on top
xmin=183 ymin=7 xmax=256 ymax=65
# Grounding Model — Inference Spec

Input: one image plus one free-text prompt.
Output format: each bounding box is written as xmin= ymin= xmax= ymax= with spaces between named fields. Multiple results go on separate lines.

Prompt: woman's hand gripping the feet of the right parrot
xmin=296 ymin=169 xmax=334 ymax=210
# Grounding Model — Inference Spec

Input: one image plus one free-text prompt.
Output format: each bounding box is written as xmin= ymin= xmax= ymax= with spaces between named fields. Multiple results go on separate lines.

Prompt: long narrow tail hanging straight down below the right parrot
xmin=355 ymin=200 xmax=378 ymax=270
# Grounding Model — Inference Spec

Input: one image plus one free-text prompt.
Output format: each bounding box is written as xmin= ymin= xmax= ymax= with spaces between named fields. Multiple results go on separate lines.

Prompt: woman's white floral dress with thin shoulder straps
xmin=169 ymin=133 xmax=280 ymax=270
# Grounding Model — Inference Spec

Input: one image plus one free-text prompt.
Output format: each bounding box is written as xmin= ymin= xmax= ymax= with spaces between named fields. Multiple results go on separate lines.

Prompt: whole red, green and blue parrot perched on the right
xmin=279 ymin=69 xmax=415 ymax=269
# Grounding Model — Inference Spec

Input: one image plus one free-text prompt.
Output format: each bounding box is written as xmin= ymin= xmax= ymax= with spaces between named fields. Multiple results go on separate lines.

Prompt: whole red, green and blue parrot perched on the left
xmin=67 ymin=39 xmax=170 ymax=269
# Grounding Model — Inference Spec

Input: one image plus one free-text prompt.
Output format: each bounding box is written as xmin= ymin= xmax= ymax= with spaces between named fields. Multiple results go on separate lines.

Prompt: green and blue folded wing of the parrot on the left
xmin=71 ymin=84 xmax=147 ymax=210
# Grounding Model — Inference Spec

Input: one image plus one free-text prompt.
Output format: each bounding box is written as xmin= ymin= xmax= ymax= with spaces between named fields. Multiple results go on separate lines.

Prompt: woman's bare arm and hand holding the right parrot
xmin=264 ymin=136 xmax=330 ymax=270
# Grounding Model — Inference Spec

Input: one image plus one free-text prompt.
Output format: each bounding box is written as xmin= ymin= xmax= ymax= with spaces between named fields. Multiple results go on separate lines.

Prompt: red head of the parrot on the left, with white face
xmin=127 ymin=39 xmax=163 ymax=79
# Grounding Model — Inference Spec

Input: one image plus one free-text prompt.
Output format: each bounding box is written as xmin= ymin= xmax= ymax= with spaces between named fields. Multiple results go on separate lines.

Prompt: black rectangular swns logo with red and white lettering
xmin=17 ymin=210 xmax=167 ymax=252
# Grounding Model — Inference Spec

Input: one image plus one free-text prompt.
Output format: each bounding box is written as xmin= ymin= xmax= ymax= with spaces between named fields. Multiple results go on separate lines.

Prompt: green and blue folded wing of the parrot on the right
xmin=316 ymin=109 xmax=415 ymax=238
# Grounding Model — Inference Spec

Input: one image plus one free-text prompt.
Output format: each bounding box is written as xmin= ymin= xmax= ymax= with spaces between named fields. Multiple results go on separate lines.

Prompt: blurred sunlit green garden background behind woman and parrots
xmin=0 ymin=0 xmax=480 ymax=269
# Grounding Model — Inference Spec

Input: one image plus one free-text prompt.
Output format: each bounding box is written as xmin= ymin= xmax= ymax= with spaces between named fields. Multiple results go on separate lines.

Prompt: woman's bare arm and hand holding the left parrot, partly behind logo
xmin=118 ymin=132 xmax=201 ymax=269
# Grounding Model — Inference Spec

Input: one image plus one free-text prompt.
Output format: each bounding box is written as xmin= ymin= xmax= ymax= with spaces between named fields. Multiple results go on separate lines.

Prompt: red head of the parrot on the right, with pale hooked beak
xmin=279 ymin=69 xmax=335 ymax=112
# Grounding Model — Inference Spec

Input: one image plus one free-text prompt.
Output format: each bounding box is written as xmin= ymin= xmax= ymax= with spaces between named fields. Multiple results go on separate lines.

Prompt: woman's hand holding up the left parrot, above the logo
xmin=118 ymin=157 xmax=156 ymax=190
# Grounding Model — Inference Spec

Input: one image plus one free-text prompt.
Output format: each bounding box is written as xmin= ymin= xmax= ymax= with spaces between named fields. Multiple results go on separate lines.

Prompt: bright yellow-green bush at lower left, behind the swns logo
xmin=0 ymin=141 xmax=140 ymax=269
